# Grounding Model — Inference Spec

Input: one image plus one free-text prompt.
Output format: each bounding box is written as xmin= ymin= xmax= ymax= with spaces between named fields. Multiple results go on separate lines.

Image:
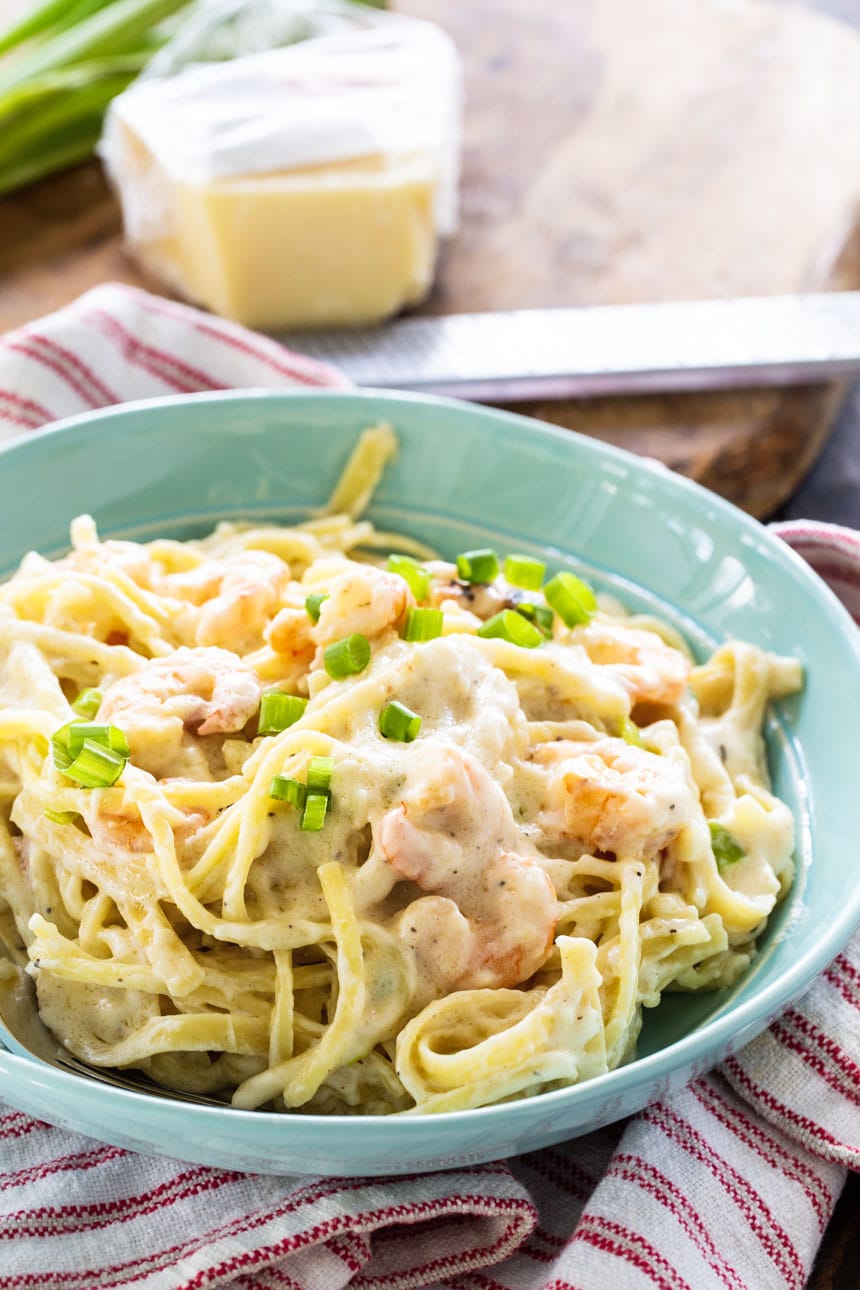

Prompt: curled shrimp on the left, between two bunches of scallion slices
xmin=98 ymin=646 xmax=263 ymax=775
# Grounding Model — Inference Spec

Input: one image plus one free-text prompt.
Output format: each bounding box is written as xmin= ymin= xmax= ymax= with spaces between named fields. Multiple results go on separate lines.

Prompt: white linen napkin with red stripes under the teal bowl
xmin=0 ymin=285 xmax=860 ymax=1290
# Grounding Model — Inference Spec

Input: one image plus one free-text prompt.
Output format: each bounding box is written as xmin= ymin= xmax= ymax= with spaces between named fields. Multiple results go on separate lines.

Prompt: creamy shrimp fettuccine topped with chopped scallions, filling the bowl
xmin=0 ymin=427 xmax=801 ymax=1113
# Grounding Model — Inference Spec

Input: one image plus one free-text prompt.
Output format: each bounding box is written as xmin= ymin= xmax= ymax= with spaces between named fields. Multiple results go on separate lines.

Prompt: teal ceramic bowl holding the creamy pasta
xmin=0 ymin=392 xmax=860 ymax=1175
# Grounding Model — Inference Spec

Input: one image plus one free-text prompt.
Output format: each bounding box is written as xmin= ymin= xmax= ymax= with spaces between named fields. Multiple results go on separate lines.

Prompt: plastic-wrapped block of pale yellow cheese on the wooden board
xmin=101 ymin=0 xmax=462 ymax=330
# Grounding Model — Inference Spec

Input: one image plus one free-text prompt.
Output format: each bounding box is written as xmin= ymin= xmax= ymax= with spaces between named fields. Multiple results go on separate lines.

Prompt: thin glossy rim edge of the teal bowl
xmin=0 ymin=387 xmax=860 ymax=1146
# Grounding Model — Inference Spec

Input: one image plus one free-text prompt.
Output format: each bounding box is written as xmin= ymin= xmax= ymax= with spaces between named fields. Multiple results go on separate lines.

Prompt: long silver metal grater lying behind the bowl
xmin=281 ymin=292 xmax=860 ymax=402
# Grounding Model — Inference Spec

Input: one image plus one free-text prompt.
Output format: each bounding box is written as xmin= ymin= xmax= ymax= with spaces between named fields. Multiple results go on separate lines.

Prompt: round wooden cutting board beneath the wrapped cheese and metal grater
xmin=0 ymin=0 xmax=860 ymax=516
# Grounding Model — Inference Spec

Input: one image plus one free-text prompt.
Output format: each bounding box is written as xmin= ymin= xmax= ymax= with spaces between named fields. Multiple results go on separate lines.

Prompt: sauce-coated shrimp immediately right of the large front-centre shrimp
xmin=534 ymin=738 xmax=692 ymax=858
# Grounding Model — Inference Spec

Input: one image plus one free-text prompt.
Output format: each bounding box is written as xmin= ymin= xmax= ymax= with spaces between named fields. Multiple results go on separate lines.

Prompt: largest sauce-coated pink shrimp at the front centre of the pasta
xmin=378 ymin=747 xmax=558 ymax=989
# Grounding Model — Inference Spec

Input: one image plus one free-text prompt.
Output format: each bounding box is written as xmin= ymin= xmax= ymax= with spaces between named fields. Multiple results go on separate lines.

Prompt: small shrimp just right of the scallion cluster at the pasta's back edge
xmin=576 ymin=622 xmax=692 ymax=706
